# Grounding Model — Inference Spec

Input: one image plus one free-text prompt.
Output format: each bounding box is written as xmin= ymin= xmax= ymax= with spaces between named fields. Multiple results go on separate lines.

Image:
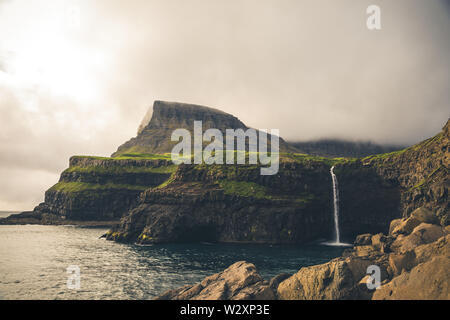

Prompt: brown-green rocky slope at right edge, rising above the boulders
xmin=361 ymin=120 xmax=450 ymax=225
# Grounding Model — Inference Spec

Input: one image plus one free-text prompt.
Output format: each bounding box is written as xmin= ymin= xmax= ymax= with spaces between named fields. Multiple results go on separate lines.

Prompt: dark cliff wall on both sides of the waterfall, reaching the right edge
xmin=108 ymin=118 xmax=449 ymax=243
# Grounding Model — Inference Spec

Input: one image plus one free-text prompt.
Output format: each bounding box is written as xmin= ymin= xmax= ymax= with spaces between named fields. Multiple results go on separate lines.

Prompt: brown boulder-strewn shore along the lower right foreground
xmin=156 ymin=208 xmax=450 ymax=300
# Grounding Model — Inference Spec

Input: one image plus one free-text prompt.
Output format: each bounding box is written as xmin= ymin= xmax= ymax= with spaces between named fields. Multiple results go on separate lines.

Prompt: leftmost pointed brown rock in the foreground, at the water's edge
xmin=157 ymin=261 xmax=275 ymax=300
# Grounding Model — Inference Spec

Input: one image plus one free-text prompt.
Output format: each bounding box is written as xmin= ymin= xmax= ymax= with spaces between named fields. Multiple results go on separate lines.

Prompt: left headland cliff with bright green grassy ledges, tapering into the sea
xmin=0 ymin=155 xmax=176 ymax=224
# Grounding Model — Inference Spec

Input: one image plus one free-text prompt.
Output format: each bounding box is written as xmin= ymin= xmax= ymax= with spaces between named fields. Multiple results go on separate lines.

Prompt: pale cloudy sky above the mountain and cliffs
xmin=0 ymin=0 xmax=450 ymax=210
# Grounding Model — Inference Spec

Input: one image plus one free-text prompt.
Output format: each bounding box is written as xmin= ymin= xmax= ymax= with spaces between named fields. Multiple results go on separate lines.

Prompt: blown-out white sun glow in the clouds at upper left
xmin=0 ymin=0 xmax=106 ymax=103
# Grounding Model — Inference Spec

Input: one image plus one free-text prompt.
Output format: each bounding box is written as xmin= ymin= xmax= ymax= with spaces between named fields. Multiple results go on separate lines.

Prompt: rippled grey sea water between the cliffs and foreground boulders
xmin=0 ymin=225 xmax=343 ymax=300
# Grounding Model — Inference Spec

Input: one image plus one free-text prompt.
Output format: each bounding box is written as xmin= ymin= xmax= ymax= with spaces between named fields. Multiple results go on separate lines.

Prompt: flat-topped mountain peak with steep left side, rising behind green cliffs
xmin=112 ymin=100 xmax=298 ymax=157
